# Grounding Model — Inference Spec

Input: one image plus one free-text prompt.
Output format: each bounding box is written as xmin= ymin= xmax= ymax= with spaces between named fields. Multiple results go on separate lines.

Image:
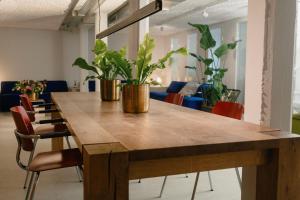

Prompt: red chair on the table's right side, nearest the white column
xmin=192 ymin=101 xmax=244 ymax=200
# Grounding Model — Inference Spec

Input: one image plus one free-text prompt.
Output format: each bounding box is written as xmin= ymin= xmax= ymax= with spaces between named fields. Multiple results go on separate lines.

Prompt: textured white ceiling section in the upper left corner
xmin=0 ymin=0 xmax=71 ymax=30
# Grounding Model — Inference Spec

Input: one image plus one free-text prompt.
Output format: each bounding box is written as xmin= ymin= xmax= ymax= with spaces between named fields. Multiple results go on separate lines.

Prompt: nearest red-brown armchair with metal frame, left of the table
xmin=10 ymin=106 xmax=82 ymax=199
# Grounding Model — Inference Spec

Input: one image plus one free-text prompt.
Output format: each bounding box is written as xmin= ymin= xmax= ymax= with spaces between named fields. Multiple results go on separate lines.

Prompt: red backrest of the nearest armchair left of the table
xmin=10 ymin=106 xmax=34 ymax=151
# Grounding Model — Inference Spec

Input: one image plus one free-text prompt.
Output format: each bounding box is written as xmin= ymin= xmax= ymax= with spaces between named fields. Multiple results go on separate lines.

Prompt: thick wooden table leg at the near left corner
xmin=83 ymin=143 xmax=129 ymax=200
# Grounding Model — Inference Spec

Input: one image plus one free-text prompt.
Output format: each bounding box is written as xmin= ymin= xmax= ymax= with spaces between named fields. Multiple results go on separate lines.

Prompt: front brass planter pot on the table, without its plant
xmin=122 ymin=84 xmax=150 ymax=113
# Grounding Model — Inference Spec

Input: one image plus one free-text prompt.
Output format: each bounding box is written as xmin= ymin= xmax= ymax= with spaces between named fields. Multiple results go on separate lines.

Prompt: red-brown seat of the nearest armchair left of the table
xmin=29 ymin=148 xmax=82 ymax=172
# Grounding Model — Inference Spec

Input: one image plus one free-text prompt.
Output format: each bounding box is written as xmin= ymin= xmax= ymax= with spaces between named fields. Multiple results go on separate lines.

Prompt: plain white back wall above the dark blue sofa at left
xmin=0 ymin=28 xmax=79 ymax=87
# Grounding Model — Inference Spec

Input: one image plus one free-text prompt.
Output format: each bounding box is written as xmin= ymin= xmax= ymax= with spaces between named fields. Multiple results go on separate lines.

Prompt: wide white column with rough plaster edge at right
xmin=245 ymin=0 xmax=296 ymax=131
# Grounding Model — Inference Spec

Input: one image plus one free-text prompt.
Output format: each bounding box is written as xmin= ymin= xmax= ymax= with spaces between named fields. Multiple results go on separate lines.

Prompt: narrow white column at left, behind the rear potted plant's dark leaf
xmin=79 ymin=25 xmax=89 ymax=92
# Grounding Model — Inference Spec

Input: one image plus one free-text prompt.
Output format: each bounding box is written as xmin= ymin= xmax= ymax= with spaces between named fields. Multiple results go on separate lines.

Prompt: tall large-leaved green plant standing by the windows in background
xmin=189 ymin=23 xmax=239 ymax=106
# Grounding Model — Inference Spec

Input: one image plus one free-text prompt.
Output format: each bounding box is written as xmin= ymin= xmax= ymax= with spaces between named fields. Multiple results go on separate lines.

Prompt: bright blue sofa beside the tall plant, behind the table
xmin=150 ymin=81 xmax=209 ymax=110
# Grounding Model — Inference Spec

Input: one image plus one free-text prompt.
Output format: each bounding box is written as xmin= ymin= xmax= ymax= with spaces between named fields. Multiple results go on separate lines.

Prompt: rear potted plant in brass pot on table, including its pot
xmin=73 ymin=40 xmax=126 ymax=101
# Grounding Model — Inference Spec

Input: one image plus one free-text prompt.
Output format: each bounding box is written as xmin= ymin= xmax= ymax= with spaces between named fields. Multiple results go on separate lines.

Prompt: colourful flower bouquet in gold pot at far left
xmin=12 ymin=80 xmax=46 ymax=101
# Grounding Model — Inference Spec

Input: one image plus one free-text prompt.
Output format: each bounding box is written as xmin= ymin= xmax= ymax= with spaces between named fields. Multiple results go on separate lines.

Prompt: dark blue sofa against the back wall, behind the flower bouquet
xmin=0 ymin=80 xmax=69 ymax=112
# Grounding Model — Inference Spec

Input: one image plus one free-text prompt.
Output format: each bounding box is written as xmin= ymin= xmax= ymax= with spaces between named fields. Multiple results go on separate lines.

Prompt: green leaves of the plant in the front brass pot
xmin=113 ymin=34 xmax=187 ymax=85
